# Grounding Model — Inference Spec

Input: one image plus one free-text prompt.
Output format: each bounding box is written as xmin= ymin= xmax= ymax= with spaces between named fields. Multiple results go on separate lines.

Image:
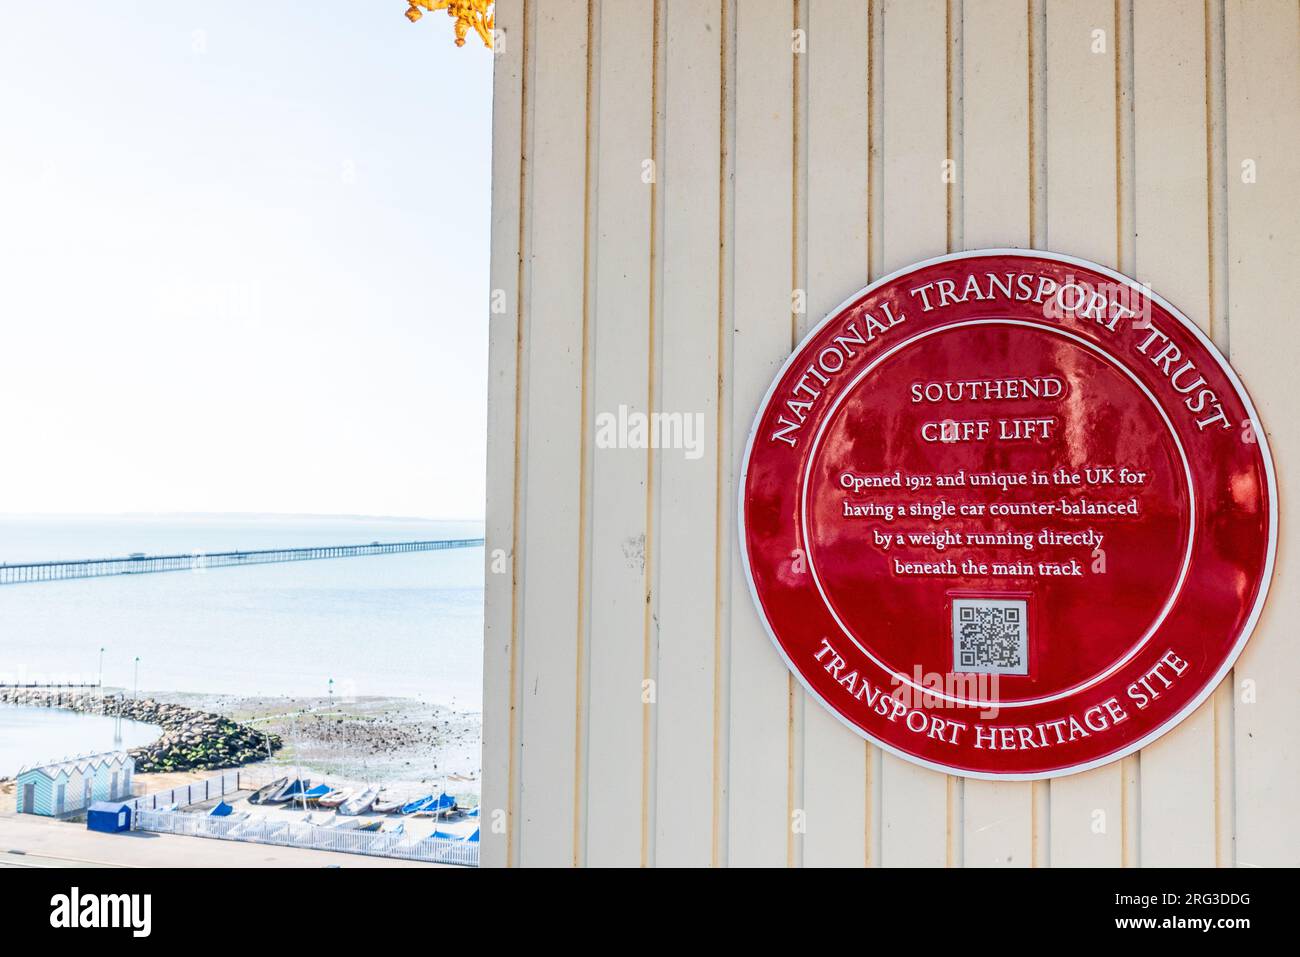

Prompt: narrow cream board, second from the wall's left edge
xmin=516 ymin=0 xmax=588 ymax=866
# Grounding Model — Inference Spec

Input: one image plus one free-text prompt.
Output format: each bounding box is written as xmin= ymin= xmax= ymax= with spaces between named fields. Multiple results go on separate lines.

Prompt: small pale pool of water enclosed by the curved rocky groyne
xmin=0 ymin=705 xmax=159 ymax=778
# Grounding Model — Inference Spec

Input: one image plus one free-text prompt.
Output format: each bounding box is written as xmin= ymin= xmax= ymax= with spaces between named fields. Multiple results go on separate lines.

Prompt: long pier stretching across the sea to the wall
xmin=0 ymin=538 xmax=484 ymax=585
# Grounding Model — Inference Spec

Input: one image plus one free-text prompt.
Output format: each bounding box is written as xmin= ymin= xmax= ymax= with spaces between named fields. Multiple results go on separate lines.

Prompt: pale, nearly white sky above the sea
xmin=0 ymin=0 xmax=493 ymax=518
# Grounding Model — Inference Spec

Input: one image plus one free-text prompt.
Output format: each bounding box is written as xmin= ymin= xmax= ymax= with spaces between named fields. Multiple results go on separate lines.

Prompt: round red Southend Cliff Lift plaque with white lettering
xmin=740 ymin=250 xmax=1277 ymax=779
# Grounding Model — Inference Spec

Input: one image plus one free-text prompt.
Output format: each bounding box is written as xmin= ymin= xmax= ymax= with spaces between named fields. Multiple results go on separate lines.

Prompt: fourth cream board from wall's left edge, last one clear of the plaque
xmin=654 ymin=0 xmax=729 ymax=866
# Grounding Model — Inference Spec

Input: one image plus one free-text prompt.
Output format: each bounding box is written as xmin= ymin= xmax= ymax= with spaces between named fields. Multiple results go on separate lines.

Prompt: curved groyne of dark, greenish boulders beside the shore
xmin=0 ymin=688 xmax=283 ymax=774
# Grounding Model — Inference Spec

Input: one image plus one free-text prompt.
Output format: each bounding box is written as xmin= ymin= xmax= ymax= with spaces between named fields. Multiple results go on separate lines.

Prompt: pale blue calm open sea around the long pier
xmin=0 ymin=516 xmax=484 ymax=712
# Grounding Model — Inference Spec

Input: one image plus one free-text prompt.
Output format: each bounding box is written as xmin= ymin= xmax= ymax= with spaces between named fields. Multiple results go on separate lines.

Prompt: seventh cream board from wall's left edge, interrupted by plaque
xmin=880 ymin=0 xmax=956 ymax=867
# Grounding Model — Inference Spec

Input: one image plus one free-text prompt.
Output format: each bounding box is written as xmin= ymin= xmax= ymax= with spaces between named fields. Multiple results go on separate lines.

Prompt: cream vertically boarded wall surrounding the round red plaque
xmin=484 ymin=0 xmax=1300 ymax=866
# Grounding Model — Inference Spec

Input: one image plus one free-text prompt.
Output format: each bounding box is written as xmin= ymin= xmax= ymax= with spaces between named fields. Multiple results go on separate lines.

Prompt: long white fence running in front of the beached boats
xmin=134 ymin=806 xmax=478 ymax=867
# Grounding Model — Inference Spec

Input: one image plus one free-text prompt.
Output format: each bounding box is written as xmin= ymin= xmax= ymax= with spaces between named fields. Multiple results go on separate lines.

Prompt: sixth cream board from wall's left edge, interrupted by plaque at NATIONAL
xmin=801 ymin=0 xmax=871 ymax=867
